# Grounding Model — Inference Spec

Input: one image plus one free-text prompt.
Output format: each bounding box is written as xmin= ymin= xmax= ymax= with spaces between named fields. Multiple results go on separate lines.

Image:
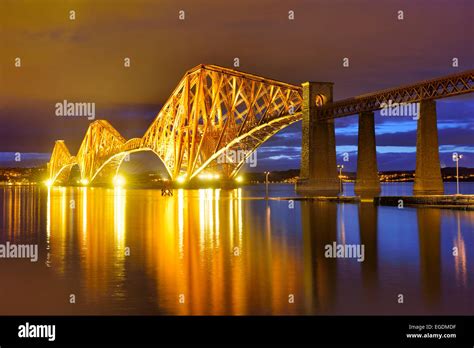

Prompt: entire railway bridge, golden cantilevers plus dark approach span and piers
xmin=48 ymin=65 xmax=474 ymax=197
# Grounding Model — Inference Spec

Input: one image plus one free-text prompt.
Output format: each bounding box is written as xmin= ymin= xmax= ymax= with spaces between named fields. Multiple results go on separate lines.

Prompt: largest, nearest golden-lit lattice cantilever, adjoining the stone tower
xmin=142 ymin=65 xmax=302 ymax=179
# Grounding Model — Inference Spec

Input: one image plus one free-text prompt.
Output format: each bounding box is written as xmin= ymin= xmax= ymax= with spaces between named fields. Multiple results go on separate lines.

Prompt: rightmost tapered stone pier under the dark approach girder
xmin=413 ymin=100 xmax=444 ymax=195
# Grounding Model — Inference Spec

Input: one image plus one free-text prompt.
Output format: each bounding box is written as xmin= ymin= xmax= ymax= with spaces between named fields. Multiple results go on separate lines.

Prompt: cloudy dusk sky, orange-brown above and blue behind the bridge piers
xmin=0 ymin=0 xmax=474 ymax=171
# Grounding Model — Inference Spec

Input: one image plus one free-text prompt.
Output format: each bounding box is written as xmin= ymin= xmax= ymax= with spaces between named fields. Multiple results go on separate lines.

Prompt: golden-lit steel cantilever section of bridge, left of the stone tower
xmin=48 ymin=65 xmax=303 ymax=184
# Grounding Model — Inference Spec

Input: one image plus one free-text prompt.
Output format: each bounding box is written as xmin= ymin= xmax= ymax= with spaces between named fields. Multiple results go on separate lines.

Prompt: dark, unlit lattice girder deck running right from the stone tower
xmin=317 ymin=70 xmax=474 ymax=119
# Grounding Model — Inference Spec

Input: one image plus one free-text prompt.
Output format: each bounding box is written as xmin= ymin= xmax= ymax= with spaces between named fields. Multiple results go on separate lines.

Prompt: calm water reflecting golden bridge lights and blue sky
xmin=0 ymin=184 xmax=474 ymax=315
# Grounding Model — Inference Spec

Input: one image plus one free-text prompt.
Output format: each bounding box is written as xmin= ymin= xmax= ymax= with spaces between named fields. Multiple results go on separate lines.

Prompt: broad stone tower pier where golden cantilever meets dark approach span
xmin=296 ymin=82 xmax=339 ymax=196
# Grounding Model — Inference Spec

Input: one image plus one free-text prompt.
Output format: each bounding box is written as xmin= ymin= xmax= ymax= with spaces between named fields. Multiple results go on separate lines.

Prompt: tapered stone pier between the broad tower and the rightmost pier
xmin=354 ymin=111 xmax=380 ymax=198
